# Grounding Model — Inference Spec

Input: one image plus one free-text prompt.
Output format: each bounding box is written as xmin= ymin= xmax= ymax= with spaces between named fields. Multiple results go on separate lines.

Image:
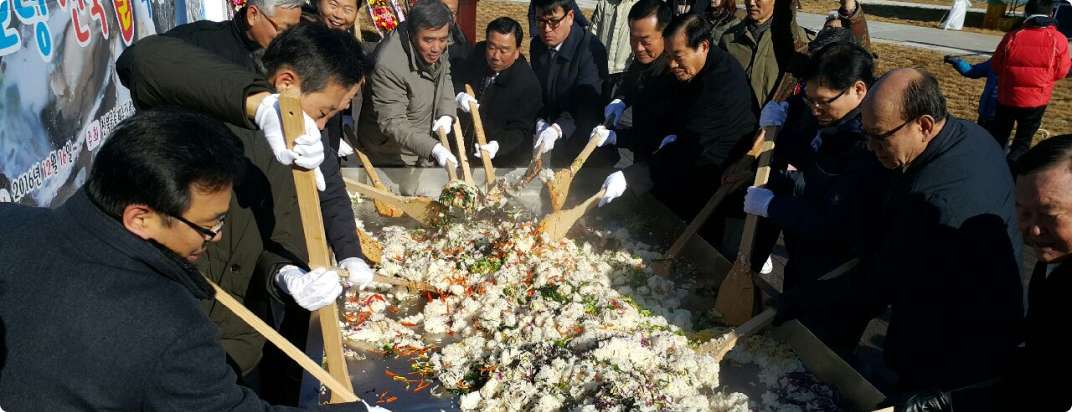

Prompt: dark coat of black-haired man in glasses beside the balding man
xmin=766 ymin=97 xmax=890 ymax=290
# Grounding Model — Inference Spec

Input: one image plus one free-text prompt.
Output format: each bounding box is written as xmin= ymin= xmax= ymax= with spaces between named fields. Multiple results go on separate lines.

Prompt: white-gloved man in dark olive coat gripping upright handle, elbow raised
xmin=116 ymin=25 xmax=371 ymax=386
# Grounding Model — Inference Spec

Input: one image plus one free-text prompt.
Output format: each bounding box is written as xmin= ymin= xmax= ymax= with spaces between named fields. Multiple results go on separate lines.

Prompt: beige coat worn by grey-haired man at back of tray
xmin=357 ymin=23 xmax=457 ymax=166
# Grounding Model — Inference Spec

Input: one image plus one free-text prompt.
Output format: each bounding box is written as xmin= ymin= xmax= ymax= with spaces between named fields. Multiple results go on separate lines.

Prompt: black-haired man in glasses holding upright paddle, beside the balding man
xmin=725 ymin=42 xmax=890 ymax=361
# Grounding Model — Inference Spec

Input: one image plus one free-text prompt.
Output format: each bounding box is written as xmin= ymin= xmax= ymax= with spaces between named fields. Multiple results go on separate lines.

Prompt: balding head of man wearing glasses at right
xmin=860 ymin=69 xmax=948 ymax=168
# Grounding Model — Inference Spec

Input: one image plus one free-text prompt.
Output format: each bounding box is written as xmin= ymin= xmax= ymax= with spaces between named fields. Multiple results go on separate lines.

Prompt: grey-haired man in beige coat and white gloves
xmin=357 ymin=1 xmax=458 ymax=166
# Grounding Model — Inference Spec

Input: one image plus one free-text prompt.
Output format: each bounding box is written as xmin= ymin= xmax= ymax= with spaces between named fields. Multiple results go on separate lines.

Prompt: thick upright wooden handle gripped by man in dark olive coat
xmin=279 ymin=90 xmax=357 ymax=403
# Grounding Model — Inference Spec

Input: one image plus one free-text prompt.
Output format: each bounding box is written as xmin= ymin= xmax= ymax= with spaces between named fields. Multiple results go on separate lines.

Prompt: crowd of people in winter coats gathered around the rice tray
xmin=0 ymin=0 xmax=1072 ymax=411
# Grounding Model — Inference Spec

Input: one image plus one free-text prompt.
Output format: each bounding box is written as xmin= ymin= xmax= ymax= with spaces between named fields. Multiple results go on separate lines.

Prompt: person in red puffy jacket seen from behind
xmin=991 ymin=0 xmax=1072 ymax=164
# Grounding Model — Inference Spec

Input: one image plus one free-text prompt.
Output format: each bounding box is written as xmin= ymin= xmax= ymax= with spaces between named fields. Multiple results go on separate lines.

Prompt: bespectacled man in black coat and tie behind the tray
xmin=530 ymin=0 xmax=619 ymax=167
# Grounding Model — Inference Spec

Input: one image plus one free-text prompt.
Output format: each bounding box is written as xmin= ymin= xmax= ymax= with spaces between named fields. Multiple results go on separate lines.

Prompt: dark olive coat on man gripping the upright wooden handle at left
xmin=116 ymin=36 xmax=313 ymax=374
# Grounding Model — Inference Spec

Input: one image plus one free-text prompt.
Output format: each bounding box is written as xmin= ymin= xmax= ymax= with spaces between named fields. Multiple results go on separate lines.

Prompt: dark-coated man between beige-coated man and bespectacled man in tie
xmin=458 ymin=17 xmax=541 ymax=167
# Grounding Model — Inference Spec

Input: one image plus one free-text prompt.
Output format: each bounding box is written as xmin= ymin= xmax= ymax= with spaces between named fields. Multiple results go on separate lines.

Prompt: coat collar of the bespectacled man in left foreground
xmin=58 ymin=189 xmax=215 ymax=299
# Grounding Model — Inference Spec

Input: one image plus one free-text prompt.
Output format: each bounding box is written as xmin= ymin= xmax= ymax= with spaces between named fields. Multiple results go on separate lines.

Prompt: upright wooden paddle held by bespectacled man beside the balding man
xmin=715 ymin=123 xmax=777 ymax=325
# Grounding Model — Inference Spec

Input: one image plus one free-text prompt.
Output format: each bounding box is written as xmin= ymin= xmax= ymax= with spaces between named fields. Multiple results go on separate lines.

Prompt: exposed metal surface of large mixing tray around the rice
xmin=302 ymin=167 xmax=883 ymax=411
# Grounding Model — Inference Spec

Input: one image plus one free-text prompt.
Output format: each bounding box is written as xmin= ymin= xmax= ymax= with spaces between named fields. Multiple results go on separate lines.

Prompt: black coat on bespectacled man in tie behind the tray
xmin=528 ymin=21 xmax=619 ymax=167
